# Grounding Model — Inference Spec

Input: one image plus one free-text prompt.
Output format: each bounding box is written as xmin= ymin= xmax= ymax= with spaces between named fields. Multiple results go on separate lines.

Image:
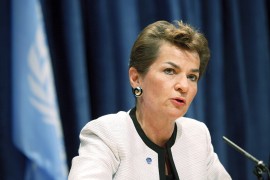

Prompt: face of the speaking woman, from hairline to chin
xmin=138 ymin=43 xmax=200 ymax=120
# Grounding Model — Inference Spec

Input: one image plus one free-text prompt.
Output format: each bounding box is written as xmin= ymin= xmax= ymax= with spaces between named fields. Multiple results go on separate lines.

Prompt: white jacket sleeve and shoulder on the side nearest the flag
xmin=69 ymin=111 xmax=130 ymax=179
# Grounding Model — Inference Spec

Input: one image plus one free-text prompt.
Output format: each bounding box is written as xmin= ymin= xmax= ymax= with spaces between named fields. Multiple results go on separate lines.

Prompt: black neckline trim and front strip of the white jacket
xmin=129 ymin=107 xmax=179 ymax=180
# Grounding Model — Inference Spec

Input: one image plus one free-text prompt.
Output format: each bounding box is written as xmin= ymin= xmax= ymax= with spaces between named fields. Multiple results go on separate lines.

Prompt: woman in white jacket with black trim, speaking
xmin=69 ymin=21 xmax=231 ymax=180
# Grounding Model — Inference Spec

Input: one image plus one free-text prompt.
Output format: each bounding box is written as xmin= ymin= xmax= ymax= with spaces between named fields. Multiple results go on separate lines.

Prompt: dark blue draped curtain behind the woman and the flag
xmin=0 ymin=0 xmax=270 ymax=180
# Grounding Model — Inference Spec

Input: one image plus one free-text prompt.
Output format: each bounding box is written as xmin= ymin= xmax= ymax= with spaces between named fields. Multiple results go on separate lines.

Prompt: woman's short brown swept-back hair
xmin=129 ymin=21 xmax=210 ymax=77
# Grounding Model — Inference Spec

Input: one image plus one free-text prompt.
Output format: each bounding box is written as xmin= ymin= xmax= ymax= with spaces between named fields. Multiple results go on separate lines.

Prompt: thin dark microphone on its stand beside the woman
xmin=223 ymin=136 xmax=270 ymax=180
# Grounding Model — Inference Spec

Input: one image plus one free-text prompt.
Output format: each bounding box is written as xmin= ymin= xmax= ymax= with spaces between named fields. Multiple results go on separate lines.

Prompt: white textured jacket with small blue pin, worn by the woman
xmin=68 ymin=109 xmax=231 ymax=180
